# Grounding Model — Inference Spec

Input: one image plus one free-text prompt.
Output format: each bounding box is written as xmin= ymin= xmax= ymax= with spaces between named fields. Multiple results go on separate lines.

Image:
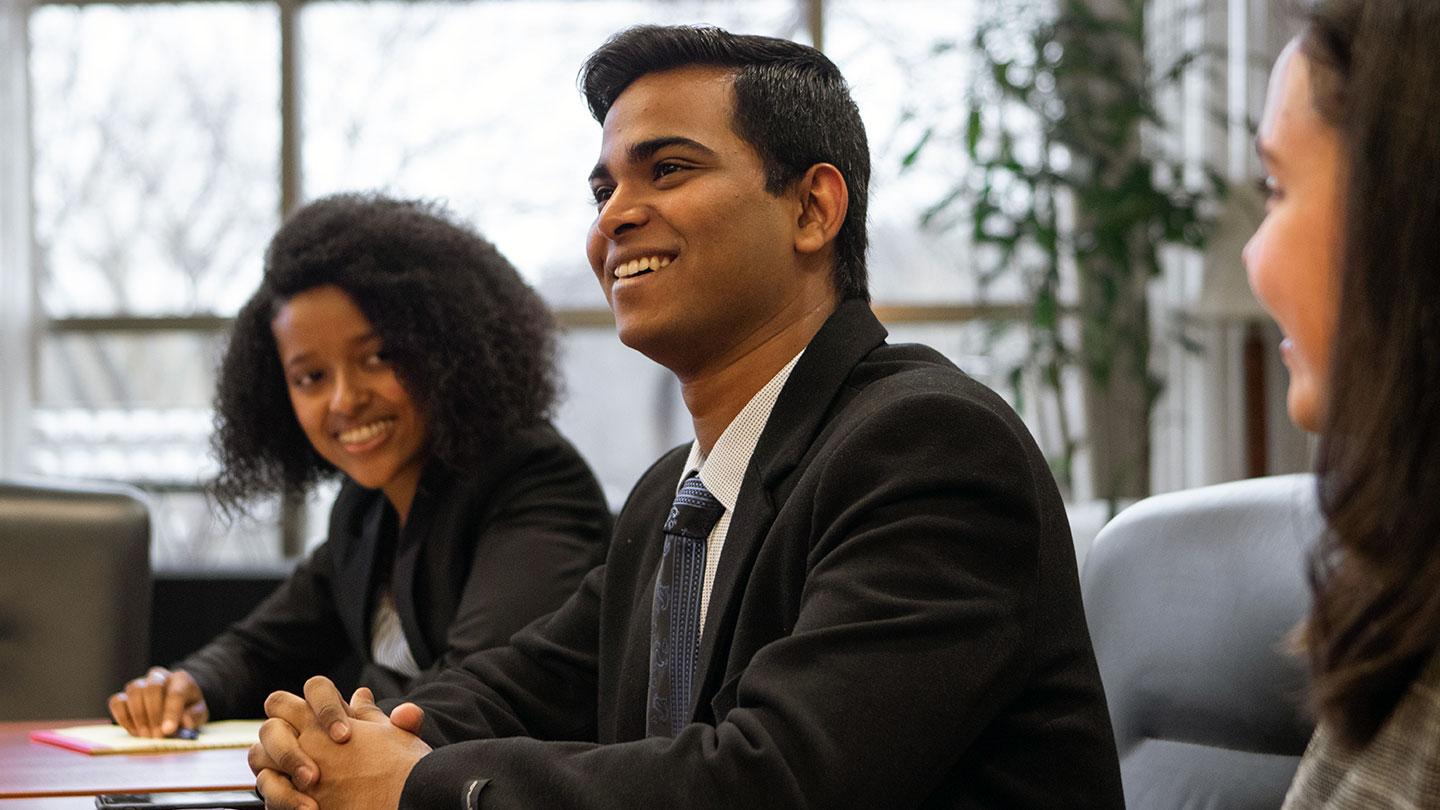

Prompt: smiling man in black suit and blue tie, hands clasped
xmin=251 ymin=27 xmax=1122 ymax=810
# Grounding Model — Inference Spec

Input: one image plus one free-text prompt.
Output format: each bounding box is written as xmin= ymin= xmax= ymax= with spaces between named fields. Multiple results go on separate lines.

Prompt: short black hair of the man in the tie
xmin=579 ymin=26 xmax=870 ymax=300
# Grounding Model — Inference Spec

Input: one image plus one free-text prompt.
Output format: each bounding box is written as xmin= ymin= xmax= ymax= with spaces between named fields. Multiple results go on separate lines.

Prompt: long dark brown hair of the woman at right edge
xmin=1302 ymin=0 xmax=1440 ymax=745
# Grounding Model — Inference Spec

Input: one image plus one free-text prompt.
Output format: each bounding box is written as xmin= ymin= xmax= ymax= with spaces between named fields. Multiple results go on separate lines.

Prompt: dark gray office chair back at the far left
xmin=0 ymin=481 xmax=151 ymax=721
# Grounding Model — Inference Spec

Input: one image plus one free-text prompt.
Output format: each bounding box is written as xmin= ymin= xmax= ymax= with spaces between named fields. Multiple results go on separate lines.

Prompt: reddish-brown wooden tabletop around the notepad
xmin=0 ymin=721 xmax=255 ymax=810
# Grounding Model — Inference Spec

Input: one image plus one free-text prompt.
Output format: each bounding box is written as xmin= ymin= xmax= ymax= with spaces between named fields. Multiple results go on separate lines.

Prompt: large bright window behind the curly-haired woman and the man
xmin=11 ymin=0 xmax=1020 ymax=566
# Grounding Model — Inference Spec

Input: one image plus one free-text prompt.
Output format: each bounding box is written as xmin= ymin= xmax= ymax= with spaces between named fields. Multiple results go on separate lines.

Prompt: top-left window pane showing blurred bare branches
xmin=30 ymin=3 xmax=279 ymax=316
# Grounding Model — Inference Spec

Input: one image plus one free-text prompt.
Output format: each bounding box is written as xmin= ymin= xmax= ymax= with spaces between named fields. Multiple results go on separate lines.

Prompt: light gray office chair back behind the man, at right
xmin=1081 ymin=476 xmax=1323 ymax=810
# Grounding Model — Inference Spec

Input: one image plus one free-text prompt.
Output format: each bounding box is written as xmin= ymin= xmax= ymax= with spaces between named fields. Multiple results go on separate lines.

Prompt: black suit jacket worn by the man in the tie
xmin=400 ymin=301 xmax=1122 ymax=810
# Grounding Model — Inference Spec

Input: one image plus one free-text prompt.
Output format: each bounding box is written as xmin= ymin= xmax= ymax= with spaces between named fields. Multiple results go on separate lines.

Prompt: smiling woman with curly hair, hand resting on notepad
xmin=109 ymin=195 xmax=609 ymax=736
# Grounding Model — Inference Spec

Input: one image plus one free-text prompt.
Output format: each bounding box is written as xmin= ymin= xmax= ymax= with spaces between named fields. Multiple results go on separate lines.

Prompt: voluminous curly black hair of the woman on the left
xmin=210 ymin=195 xmax=556 ymax=513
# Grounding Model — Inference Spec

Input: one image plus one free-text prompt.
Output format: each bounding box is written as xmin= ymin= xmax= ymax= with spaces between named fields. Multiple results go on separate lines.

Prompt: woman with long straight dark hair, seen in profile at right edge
xmin=1246 ymin=0 xmax=1440 ymax=795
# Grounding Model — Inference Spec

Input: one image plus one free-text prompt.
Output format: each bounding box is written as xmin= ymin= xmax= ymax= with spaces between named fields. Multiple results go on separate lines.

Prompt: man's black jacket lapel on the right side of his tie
xmin=691 ymin=300 xmax=887 ymax=716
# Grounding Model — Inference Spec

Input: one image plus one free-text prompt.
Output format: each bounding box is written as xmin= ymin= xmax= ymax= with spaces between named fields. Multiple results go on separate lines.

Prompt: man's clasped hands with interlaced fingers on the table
xmin=249 ymin=676 xmax=431 ymax=810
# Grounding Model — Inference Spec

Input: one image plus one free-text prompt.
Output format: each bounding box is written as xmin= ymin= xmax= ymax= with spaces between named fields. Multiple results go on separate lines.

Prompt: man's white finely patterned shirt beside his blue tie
xmin=675 ymin=350 xmax=805 ymax=628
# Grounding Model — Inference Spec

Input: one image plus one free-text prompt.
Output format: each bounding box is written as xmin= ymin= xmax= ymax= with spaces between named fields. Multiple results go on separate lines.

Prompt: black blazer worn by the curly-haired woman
xmin=176 ymin=425 xmax=611 ymax=719
